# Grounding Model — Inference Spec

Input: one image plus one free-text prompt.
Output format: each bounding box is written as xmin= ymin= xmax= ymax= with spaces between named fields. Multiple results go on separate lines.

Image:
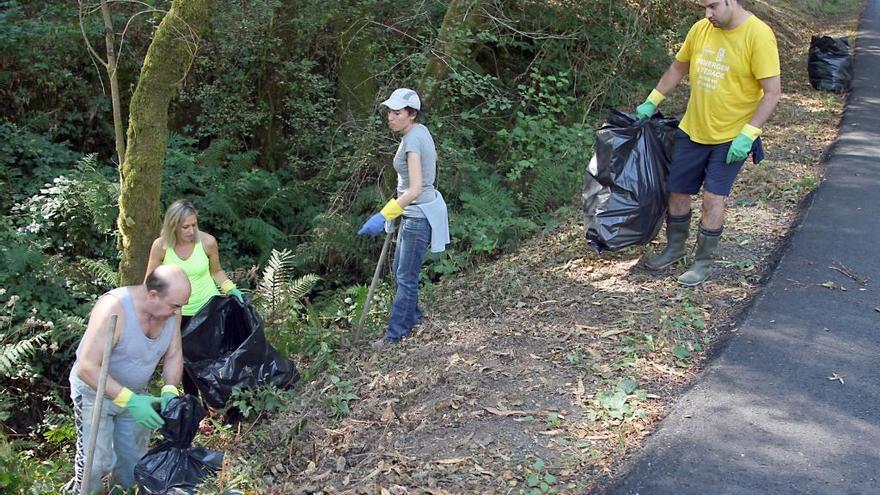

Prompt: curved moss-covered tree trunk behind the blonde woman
xmin=118 ymin=0 xmax=218 ymax=285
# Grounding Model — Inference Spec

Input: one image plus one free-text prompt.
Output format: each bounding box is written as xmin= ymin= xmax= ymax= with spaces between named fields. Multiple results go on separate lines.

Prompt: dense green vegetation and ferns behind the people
xmin=0 ymin=0 xmax=700 ymax=493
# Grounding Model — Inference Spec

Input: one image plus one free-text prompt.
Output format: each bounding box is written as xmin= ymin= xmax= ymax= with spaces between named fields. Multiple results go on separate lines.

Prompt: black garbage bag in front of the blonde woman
xmin=183 ymin=297 xmax=299 ymax=408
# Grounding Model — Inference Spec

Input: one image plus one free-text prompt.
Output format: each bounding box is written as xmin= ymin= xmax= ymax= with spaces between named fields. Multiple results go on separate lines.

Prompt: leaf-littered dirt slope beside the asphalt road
xmin=217 ymin=2 xmax=856 ymax=495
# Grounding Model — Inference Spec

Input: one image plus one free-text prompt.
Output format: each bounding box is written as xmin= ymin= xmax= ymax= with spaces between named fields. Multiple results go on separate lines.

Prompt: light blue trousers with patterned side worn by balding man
xmin=70 ymin=377 xmax=151 ymax=493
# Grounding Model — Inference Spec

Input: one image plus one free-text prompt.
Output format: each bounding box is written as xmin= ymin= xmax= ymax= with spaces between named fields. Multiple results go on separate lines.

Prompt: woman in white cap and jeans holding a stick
xmin=358 ymin=88 xmax=449 ymax=349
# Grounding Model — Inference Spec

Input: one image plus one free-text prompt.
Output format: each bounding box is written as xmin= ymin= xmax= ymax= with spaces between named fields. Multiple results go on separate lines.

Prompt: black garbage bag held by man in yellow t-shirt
xmin=583 ymin=110 xmax=678 ymax=252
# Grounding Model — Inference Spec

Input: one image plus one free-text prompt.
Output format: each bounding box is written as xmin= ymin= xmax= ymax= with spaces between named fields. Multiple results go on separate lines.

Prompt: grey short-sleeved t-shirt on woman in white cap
xmin=394 ymin=124 xmax=437 ymax=217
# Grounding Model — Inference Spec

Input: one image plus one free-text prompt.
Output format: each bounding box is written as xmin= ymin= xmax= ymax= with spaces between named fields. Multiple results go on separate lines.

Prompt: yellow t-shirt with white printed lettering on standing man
xmin=675 ymin=15 xmax=781 ymax=144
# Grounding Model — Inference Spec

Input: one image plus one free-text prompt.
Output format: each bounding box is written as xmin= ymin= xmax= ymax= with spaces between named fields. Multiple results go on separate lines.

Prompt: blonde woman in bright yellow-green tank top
xmin=147 ymin=199 xmax=243 ymax=329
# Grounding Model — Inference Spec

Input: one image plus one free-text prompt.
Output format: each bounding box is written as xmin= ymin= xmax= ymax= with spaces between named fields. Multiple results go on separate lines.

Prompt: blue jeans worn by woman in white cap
xmin=385 ymin=217 xmax=431 ymax=342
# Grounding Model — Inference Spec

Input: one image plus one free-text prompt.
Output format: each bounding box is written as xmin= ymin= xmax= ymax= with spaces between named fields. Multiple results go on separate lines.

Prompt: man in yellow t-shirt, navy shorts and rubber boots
xmin=636 ymin=0 xmax=782 ymax=286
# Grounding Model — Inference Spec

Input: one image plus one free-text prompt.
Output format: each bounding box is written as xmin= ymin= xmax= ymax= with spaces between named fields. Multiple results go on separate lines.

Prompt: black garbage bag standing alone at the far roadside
xmin=807 ymin=36 xmax=853 ymax=93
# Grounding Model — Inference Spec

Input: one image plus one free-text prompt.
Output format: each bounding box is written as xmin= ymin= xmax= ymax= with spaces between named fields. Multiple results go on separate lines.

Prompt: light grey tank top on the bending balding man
xmin=72 ymin=287 xmax=177 ymax=392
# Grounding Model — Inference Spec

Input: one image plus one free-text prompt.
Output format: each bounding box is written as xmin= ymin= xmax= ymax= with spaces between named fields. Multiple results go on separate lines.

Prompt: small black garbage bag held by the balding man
xmin=134 ymin=395 xmax=223 ymax=495
